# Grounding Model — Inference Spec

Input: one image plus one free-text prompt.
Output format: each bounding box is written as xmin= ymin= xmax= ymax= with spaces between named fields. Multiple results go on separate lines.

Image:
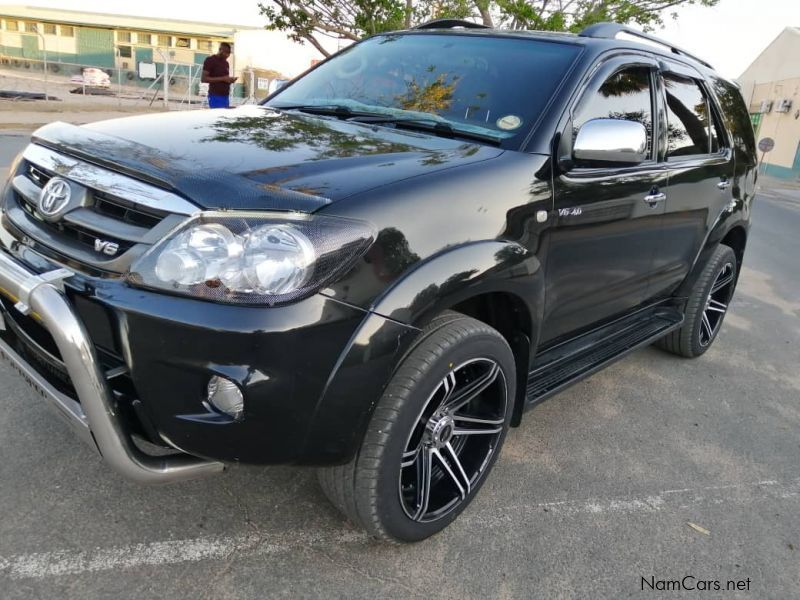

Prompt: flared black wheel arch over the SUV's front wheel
xmin=305 ymin=240 xmax=544 ymax=463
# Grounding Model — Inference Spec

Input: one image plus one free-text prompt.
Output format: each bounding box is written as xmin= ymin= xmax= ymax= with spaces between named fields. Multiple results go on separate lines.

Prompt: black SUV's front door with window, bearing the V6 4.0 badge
xmin=540 ymin=56 xmax=667 ymax=344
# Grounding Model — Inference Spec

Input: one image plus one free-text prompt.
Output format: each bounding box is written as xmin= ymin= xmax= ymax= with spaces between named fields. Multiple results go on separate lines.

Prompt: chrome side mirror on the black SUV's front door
xmin=572 ymin=119 xmax=647 ymax=165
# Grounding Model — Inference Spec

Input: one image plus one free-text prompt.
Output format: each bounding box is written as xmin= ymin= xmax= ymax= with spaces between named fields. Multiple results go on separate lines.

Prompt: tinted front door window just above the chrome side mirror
xmin=574 ymin=67 xmax=653 ymax=155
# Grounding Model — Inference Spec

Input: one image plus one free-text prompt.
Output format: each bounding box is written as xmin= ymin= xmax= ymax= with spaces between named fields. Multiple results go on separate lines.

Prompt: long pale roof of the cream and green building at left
xmin=0 ymin=4 xmax=261 ymax=38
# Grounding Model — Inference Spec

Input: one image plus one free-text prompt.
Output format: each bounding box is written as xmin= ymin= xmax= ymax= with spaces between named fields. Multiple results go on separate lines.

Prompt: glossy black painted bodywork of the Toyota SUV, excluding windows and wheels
xmin=0 ymin=32 xmax=755 ymax=464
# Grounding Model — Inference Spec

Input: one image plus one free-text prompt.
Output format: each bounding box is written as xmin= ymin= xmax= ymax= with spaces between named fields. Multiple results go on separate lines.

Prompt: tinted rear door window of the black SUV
xmin=664 ymin=75 xmax=719 ymax=158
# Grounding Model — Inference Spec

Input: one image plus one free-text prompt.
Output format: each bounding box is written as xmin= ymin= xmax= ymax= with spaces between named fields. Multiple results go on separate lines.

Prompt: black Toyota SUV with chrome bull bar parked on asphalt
xmin=0 ymin=21 xmax=756 ymax=542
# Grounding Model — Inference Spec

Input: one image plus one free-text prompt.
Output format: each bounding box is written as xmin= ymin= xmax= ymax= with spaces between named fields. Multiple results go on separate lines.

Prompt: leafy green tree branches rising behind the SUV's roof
xmin=258 ymin=0 xmax=719 ymax=56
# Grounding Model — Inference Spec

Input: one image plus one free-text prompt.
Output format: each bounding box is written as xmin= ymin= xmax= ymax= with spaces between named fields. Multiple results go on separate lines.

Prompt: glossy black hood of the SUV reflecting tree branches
xmin=34 ymin=106 xmax=503 ymax=212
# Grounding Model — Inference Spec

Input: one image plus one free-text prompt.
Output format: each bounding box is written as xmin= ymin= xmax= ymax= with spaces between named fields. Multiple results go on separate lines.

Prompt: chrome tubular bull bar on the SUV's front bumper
xmin=0 ymin=251 xmax=225 ymax=483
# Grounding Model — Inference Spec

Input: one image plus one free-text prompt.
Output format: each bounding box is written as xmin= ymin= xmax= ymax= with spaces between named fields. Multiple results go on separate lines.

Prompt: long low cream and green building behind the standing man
xmin=0 ymin=5 xmax=318 ymax=96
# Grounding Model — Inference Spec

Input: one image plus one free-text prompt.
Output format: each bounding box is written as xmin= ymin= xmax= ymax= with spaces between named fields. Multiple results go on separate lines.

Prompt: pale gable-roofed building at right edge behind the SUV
xmin=738 ymin=27 xmax=800 ymax=179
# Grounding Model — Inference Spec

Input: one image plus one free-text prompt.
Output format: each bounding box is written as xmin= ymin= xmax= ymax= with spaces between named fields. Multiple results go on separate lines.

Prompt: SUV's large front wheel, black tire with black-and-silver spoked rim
xmin=318 ymin=311 xmax=516 ymax=543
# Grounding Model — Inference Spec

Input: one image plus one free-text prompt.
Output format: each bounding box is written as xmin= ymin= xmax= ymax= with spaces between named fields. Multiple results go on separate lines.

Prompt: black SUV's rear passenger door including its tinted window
xmin=649 ymin=62 xmax=735 ymax=297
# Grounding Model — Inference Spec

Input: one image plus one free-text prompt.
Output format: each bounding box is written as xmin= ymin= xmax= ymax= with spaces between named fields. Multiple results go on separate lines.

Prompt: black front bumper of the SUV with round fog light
xmin=0 ymin=237 xmax=417 ymax=472
